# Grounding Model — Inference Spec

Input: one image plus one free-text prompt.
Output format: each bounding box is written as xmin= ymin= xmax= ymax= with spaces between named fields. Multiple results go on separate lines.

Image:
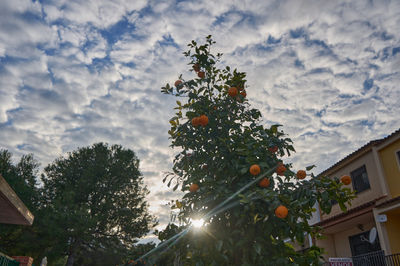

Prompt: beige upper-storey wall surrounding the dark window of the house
xmin=322 ymin=151 xmax=383 ymax=220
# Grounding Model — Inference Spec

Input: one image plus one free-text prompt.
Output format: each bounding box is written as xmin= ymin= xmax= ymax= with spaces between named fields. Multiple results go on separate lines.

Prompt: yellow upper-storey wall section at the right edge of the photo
xmin=379 ymin=139 xmax=400 ymax=198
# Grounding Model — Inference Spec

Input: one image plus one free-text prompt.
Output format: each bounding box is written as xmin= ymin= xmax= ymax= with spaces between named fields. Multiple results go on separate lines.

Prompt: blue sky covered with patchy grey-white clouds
xmin=0 ymin=0 xmax=400 ymax=237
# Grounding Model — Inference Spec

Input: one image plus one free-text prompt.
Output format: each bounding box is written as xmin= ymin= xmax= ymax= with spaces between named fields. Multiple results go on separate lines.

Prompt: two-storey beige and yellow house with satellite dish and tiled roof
xmin=313 ymin=129 xmax=400 ymax=259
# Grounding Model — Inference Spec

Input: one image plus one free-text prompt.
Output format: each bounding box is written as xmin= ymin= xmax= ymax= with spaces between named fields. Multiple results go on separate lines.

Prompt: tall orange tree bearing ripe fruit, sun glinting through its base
xmin=161 ymin=36 xmax=354 ymax=265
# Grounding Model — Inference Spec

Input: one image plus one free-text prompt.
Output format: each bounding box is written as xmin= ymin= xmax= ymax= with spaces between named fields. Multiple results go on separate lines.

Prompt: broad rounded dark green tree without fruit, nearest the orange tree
xmin=42 ymin=143 xmax=155 ymax=265
